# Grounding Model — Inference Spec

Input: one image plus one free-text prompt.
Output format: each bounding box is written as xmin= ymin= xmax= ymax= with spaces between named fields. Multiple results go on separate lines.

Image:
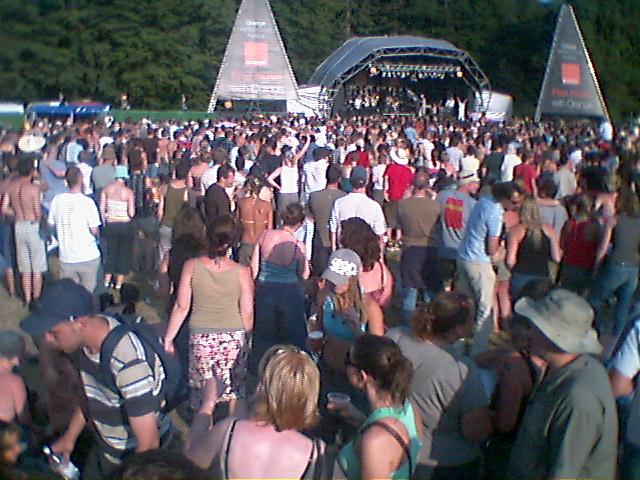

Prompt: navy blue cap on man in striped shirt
xmin=20 ymin=278 xmax=94 ymax=335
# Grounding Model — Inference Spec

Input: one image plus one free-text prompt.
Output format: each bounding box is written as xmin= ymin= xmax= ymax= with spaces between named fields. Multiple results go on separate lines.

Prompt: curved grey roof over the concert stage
xmin=309 ymin=36 xmax=466 ymax=88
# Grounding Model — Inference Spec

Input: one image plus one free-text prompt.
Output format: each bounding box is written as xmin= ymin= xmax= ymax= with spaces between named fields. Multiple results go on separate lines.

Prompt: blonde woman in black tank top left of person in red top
xmin=506 ymin=197 xmax=562 ymax=298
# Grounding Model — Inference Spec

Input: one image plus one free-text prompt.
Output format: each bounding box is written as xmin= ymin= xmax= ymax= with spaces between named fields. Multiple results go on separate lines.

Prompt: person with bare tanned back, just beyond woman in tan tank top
xmin=236 ymin=177 xmax=273 ymax=266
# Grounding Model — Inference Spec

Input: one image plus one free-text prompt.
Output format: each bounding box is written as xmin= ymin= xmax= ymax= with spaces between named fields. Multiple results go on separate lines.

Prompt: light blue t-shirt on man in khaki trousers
xmin=458 ymin=196 xmax=504 ymax=263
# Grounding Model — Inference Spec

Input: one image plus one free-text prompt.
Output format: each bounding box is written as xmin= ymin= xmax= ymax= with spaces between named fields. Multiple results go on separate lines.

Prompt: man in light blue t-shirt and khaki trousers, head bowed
xmin=456 ymin=182 xmax=523 ymax=353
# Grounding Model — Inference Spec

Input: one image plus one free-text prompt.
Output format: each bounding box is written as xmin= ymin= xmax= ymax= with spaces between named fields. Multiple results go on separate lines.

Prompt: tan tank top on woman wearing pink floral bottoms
xmin=189 ymin=259 xmax=243 ymax=333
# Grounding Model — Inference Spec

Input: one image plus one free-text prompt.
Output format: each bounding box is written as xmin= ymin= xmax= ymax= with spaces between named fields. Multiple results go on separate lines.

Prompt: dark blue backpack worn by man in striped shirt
xmin=100 ymin=314 xmax=188 ymax=413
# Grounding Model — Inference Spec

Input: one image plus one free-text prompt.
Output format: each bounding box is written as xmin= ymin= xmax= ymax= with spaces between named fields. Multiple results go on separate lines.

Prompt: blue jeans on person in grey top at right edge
xmin=589 ymin=262 xmax=639 ymax=336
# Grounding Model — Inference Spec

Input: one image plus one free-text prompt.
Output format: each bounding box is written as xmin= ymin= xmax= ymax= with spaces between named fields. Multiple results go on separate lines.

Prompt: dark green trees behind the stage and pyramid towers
xmin=0 ymin=0 xmax=640 ymax=119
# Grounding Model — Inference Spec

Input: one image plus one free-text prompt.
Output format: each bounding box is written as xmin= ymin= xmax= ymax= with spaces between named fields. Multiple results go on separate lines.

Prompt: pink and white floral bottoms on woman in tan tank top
xmin=189 ymin=330 xmax=249 ymax=409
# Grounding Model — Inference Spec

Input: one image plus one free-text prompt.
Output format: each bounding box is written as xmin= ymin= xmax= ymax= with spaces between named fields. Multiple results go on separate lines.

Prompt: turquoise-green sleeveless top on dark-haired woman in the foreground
xmin=337 ymin=400 xmax=422 ymax=480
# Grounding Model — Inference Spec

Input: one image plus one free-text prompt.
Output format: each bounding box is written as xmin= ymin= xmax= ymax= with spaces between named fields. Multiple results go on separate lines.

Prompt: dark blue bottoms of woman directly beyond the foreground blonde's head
xmin=249 ymin=281 xmax=307 ymax=375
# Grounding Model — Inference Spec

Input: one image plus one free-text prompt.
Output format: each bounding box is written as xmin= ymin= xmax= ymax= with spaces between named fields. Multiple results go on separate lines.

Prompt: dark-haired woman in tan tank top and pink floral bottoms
xmin=164 ymin=215 xmax=253 ymax=414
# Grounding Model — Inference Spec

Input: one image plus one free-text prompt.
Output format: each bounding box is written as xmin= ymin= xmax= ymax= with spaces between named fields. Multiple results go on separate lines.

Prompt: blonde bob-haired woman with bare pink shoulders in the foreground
xmin=185 ymin=345 xmax=331 ymax=479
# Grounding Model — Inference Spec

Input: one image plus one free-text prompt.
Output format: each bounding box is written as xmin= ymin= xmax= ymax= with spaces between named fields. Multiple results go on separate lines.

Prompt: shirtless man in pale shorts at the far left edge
xmin=0 ymin=158 xmax=47 ymax=308
